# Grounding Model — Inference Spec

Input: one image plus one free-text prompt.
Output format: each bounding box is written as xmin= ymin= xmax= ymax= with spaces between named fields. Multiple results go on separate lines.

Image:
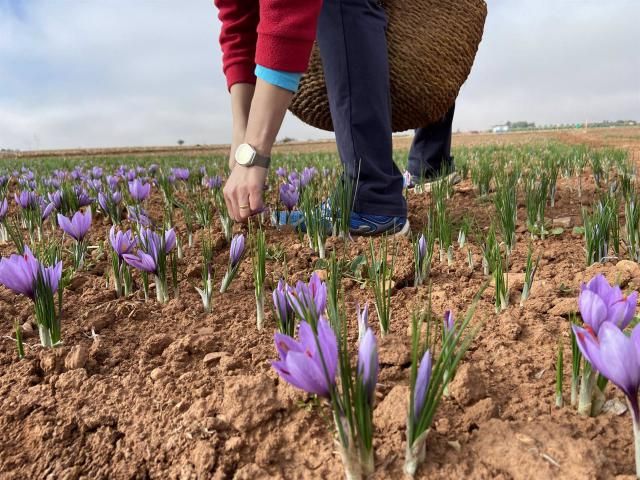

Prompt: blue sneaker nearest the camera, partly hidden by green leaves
xmin=278 ymin=210 xmax=410 ymax=236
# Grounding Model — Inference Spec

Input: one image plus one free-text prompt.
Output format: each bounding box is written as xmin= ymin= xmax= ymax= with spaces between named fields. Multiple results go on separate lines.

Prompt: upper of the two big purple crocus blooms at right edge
xmin=578 ymin=274 xmax=638 ymax=336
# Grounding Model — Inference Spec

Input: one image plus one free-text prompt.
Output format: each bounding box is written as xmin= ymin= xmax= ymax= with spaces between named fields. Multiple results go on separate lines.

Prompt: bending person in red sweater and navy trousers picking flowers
xmin=214 ymin=0 xmax=454 ymax=235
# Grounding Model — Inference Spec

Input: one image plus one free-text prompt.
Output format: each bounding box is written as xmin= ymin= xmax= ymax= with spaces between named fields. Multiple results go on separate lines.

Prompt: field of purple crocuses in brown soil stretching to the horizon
xmin=0 ymin=128 xmax=640 ymax=479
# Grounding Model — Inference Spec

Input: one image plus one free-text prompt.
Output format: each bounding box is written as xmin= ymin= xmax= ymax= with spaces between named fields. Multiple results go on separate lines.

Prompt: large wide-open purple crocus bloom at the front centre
xmin=271 ymin=318 xmax=338 ymax=398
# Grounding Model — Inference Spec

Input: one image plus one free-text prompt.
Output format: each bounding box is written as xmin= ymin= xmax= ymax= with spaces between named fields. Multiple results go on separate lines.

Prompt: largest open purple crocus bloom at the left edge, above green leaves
xmin=0 ymin=246 xmax=62 ymax=300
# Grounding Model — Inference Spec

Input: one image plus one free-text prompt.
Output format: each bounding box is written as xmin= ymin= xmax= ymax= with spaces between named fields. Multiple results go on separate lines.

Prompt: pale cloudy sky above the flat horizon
xmin=0 ymin=0 xmax=640 ymax=150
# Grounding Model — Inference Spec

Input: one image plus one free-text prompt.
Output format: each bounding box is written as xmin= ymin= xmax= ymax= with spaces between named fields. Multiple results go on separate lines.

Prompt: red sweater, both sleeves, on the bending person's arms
xmin=214 ymin=0 xmax=322 ymax=88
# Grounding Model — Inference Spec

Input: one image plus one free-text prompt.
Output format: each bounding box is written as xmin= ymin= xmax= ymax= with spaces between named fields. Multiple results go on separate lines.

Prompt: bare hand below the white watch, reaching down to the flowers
xmin=222 ymin=163 xmax=268 ymax=222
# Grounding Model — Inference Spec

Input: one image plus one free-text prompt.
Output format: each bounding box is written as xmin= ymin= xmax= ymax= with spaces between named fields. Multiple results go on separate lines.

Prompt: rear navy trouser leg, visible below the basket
xmin=408 ymin=105 xmax=455 ymax=179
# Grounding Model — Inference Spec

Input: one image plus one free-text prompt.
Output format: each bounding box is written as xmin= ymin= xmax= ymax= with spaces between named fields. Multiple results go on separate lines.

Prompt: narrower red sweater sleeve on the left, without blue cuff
xmin=214 ymin=0 xmax=260 ymax=88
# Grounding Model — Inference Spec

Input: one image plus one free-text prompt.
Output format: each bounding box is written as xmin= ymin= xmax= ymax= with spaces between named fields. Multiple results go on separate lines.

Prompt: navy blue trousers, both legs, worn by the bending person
xmin=318 ymin=0 xmax=453 ymax=216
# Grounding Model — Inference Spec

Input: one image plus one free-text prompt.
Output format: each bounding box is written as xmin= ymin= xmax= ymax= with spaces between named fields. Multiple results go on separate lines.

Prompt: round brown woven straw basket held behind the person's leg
xmin=290 ymin=0 xmax=487 ymax=132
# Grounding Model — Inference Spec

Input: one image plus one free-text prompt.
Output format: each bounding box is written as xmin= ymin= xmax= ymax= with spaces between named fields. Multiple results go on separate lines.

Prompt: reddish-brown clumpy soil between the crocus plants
xmin=0 ymin=129 xmax=640 ymax=479
